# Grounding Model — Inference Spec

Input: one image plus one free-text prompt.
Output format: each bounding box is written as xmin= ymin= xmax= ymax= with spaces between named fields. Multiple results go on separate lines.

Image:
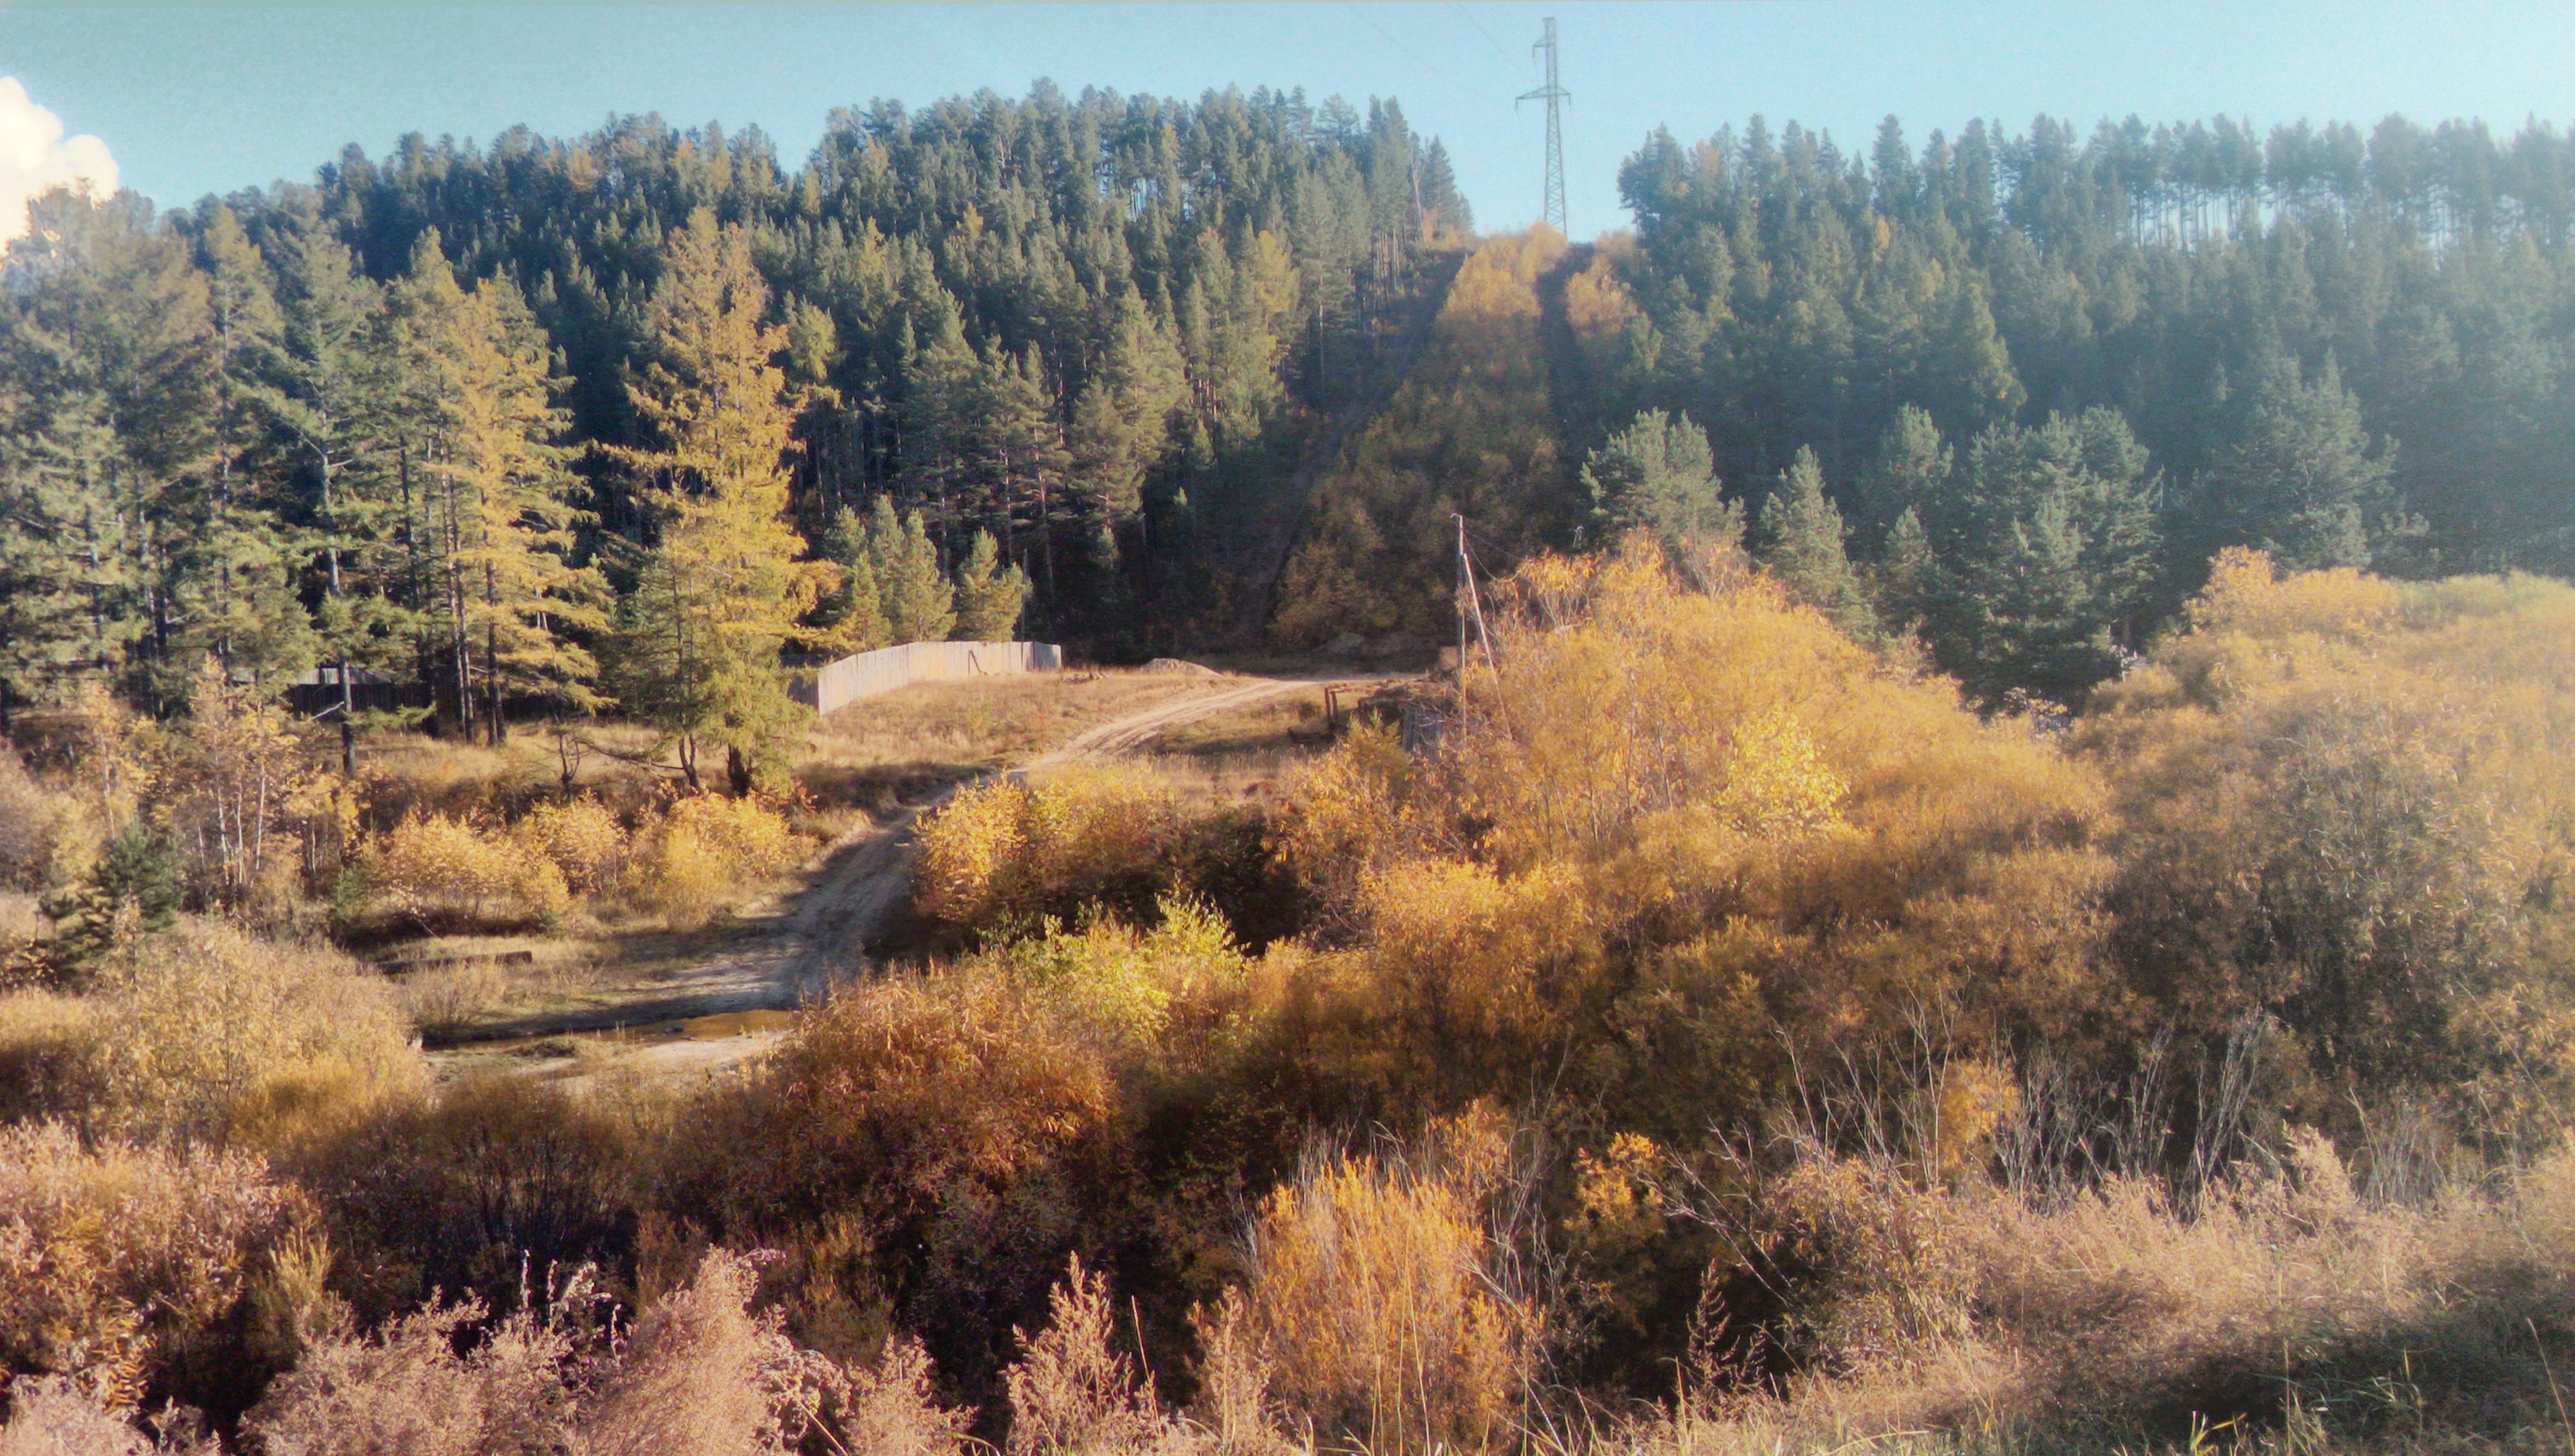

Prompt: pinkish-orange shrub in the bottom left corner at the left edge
xmin=0 ymin=1121 xmax=317 ymax=1410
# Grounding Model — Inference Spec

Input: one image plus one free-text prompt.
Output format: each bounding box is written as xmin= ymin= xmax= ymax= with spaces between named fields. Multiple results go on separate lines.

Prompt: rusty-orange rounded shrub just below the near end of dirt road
xmin=667 ymin=970 xmax=1120 ymax=1389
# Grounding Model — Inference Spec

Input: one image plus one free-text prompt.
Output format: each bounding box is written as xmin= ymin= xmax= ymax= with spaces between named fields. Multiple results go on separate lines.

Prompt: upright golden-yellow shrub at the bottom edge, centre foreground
xmin=1244 ymin=1111 xmax=1545 ymax=1451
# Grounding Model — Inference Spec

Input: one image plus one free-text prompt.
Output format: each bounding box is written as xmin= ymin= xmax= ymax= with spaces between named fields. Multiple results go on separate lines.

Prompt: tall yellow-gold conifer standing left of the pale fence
xmin=615 ymin=208 xmax=832 ymax=792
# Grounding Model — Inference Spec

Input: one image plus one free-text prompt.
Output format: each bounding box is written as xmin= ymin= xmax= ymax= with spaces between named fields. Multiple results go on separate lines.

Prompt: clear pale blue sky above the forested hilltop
xmin=0 ymin=0 xmax=2575 ymax=237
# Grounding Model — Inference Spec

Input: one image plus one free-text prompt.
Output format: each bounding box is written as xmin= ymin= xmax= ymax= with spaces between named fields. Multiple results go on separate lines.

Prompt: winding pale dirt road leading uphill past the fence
xmin=438 ymin=677 xmax=1354 ymax=1076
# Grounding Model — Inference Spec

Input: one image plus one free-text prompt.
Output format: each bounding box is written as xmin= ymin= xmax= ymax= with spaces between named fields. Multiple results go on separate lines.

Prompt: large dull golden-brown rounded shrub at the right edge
xmin=2081 ymin=550 xmax=2575 ymax=1145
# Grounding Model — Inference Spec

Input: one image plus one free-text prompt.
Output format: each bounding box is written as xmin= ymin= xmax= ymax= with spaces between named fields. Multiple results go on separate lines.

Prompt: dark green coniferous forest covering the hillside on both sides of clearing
xmin=0 ymin=98 xmax=2575 ymax=723
